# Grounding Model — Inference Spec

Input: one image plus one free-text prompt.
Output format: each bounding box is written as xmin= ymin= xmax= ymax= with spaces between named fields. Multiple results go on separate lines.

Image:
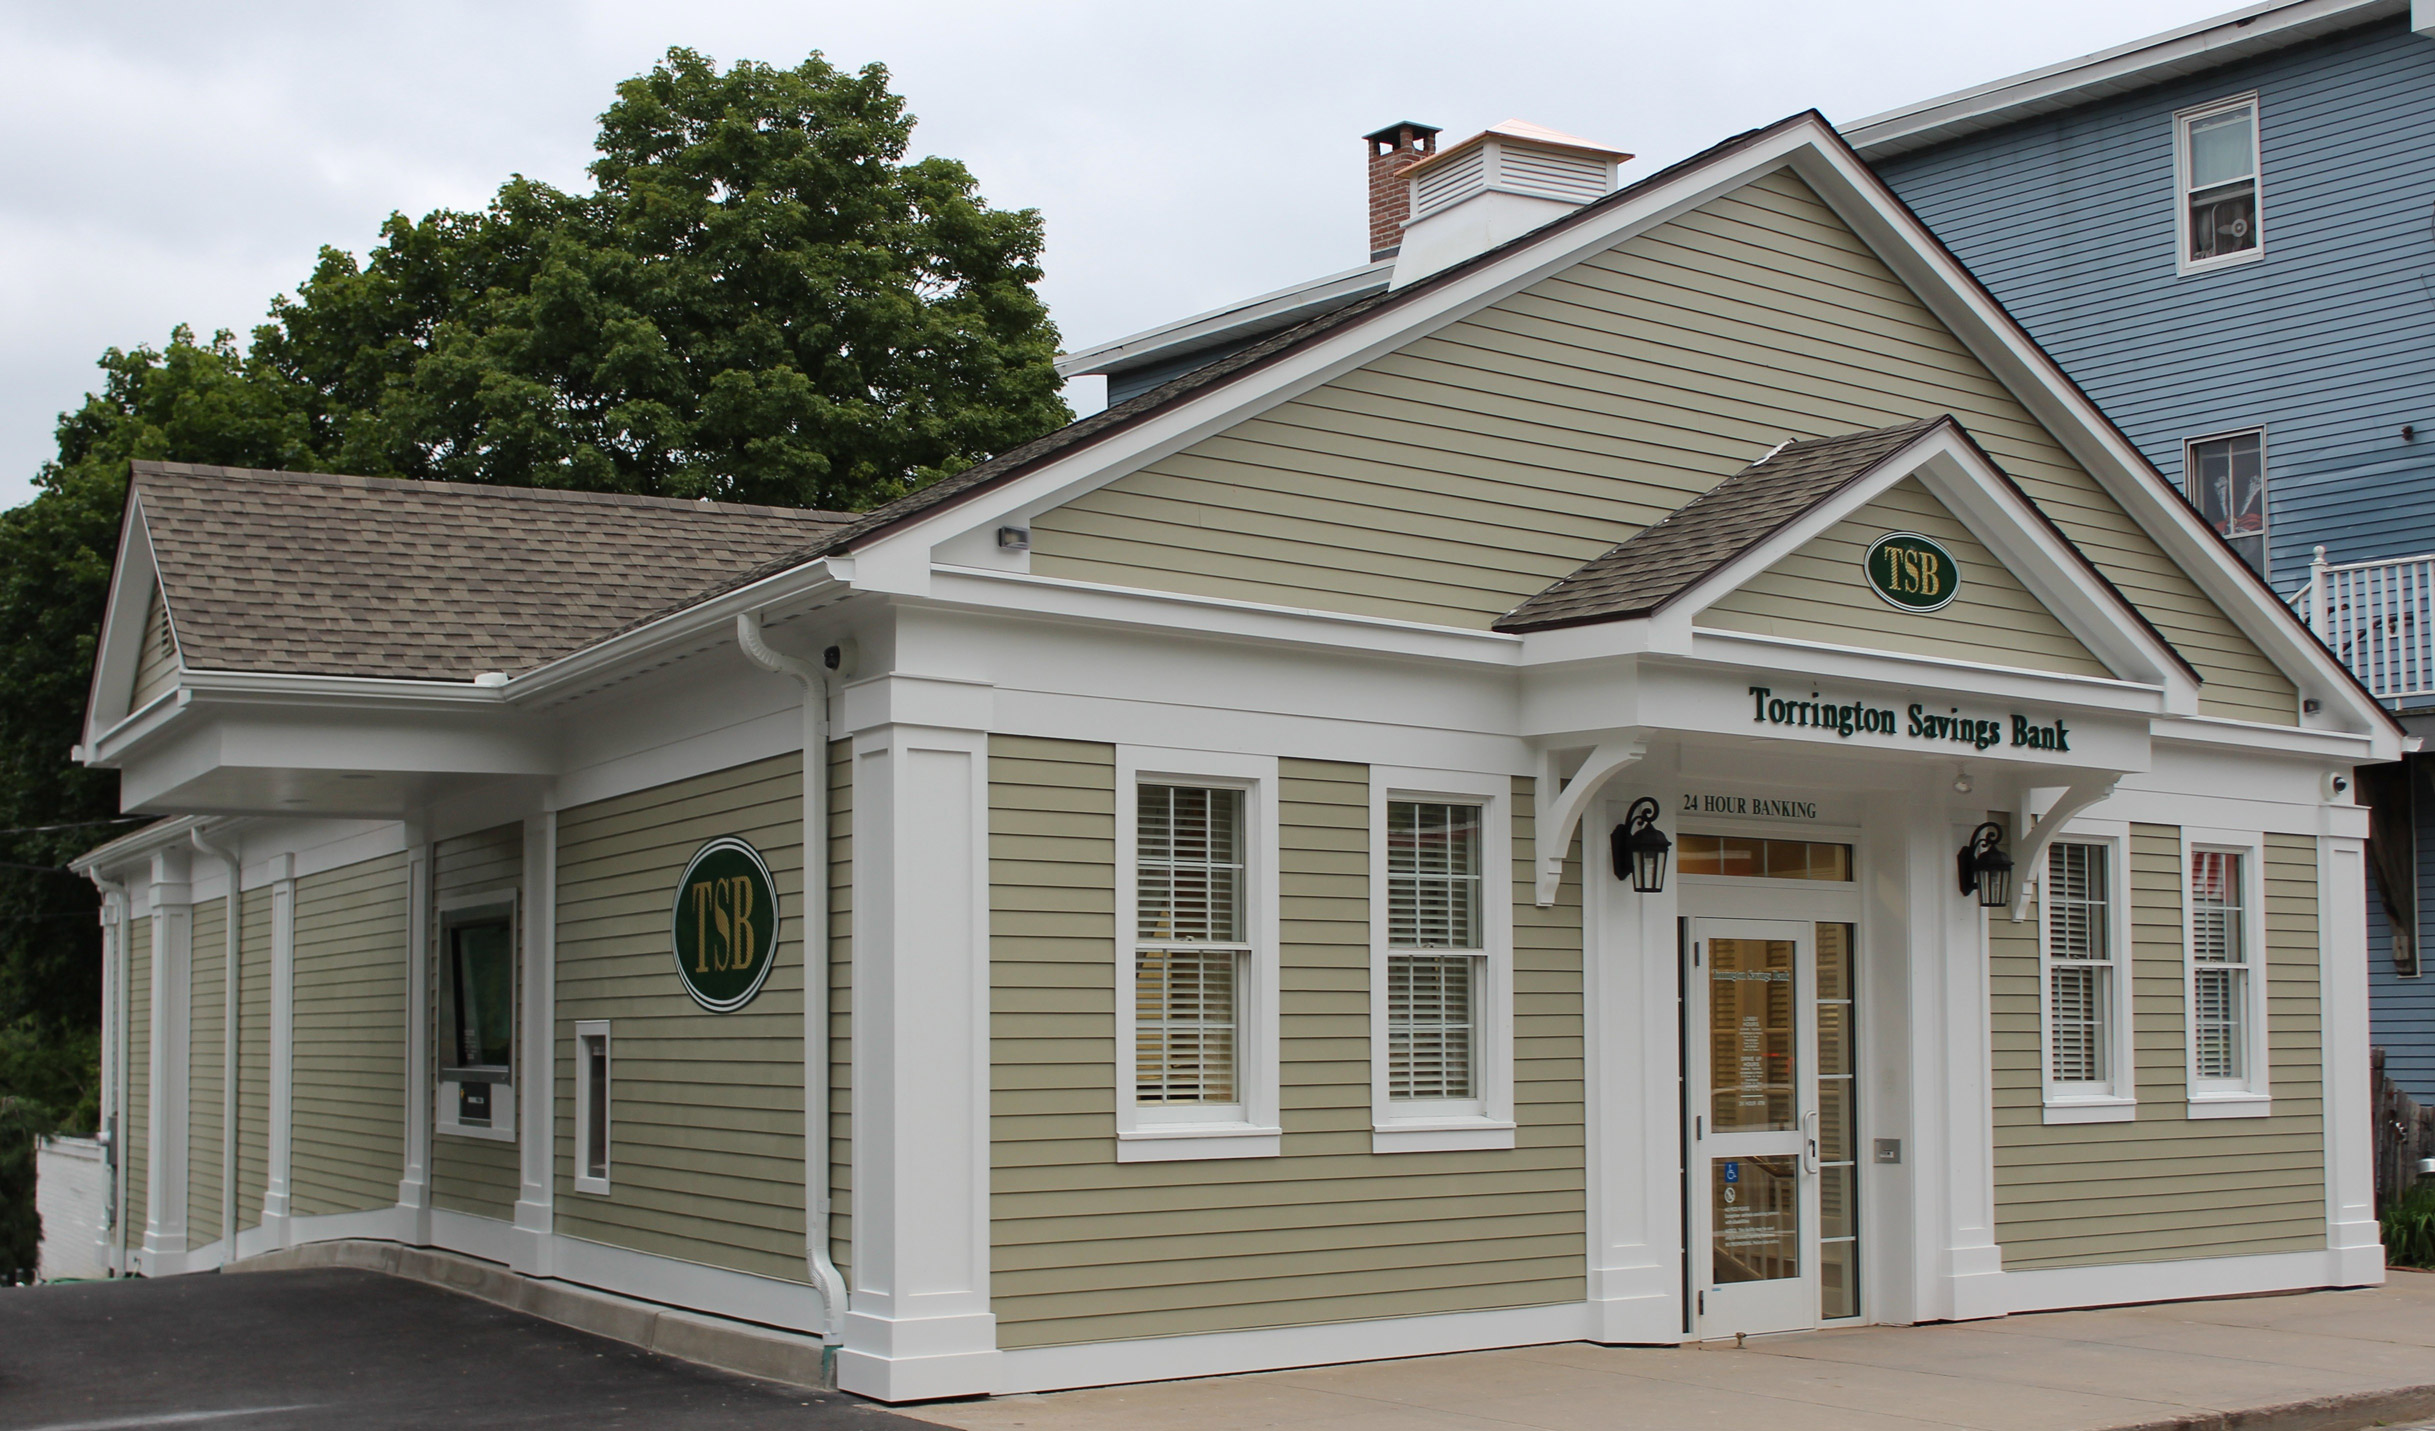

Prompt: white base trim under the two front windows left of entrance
xmin=989 ymin=1302 xmax=1590 ymax=1397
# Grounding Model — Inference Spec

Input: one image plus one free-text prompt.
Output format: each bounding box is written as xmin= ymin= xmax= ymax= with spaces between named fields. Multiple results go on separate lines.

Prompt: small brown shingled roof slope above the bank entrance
xmin=1495 ymin=416 xmax=1960 ymax=630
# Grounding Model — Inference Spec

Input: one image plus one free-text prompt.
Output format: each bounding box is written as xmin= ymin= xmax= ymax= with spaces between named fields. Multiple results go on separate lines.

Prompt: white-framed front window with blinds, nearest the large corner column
xmin=1118 ymin=747 xmax=1278 ymax=1161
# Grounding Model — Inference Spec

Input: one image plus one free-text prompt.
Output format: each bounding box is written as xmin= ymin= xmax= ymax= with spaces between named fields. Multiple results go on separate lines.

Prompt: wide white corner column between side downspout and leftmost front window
xmin=838 ymin=677 xmax=998 ymax=1402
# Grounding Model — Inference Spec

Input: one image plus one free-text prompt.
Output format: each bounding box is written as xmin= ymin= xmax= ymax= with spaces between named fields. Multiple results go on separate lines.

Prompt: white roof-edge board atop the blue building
xmin=1843 ymin=0 xmax=2411 ymax=161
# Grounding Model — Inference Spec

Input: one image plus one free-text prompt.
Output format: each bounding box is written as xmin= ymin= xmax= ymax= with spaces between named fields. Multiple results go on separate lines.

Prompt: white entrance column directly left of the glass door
xmin=1541 ymin=771 xmax=1683 ymax=1343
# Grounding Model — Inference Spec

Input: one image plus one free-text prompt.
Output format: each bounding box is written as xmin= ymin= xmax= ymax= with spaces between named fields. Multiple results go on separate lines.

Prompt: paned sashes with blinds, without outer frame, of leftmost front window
xmin=1132 ymin=784 xmax=1252 ymax=1105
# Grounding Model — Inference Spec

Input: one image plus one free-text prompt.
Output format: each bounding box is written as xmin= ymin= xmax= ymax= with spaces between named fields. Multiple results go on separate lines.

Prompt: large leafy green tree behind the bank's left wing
xmin=0 ymin=49 xmax=1069 ymax=1168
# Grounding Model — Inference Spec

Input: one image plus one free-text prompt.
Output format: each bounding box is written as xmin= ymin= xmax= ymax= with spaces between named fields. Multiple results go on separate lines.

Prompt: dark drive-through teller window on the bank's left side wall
xmin=438 ymin=903 xmax=516 ymax=1139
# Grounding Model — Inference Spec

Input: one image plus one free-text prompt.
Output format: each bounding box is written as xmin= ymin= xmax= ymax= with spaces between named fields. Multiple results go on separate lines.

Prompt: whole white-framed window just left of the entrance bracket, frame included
xmin=1371 ymin=767 xmax=1515 ymax=1151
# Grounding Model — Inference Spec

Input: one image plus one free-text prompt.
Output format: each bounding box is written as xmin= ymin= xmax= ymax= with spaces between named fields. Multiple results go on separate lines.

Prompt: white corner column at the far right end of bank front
xmin=2316 ymin=835 xmax=2384 ymax=1287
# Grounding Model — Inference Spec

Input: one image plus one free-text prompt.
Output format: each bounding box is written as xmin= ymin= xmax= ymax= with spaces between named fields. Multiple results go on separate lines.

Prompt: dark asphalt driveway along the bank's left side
xmin=0 ymin=1268 xmax=937 ymax=1431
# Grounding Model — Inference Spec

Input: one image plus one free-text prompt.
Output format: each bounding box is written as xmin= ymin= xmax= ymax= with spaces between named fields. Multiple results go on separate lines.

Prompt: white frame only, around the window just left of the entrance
xmin=1368 ymin=767 xmax=1515 ymax=1154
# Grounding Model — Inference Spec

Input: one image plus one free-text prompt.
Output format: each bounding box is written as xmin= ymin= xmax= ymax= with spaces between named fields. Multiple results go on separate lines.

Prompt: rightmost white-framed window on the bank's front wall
xmin=2184 ymin=835 xmax=2267 ymax=1117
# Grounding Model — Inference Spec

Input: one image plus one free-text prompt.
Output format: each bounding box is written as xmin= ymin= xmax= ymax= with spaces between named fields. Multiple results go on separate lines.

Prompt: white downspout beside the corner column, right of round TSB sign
xmin=735 ymin=611 xmax=845 ymax=1385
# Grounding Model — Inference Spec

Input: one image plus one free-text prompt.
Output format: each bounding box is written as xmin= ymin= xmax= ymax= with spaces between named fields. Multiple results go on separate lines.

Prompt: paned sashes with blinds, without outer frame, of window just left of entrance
xmin=1386 ymin=801 xmax=1485 ymax=1100
